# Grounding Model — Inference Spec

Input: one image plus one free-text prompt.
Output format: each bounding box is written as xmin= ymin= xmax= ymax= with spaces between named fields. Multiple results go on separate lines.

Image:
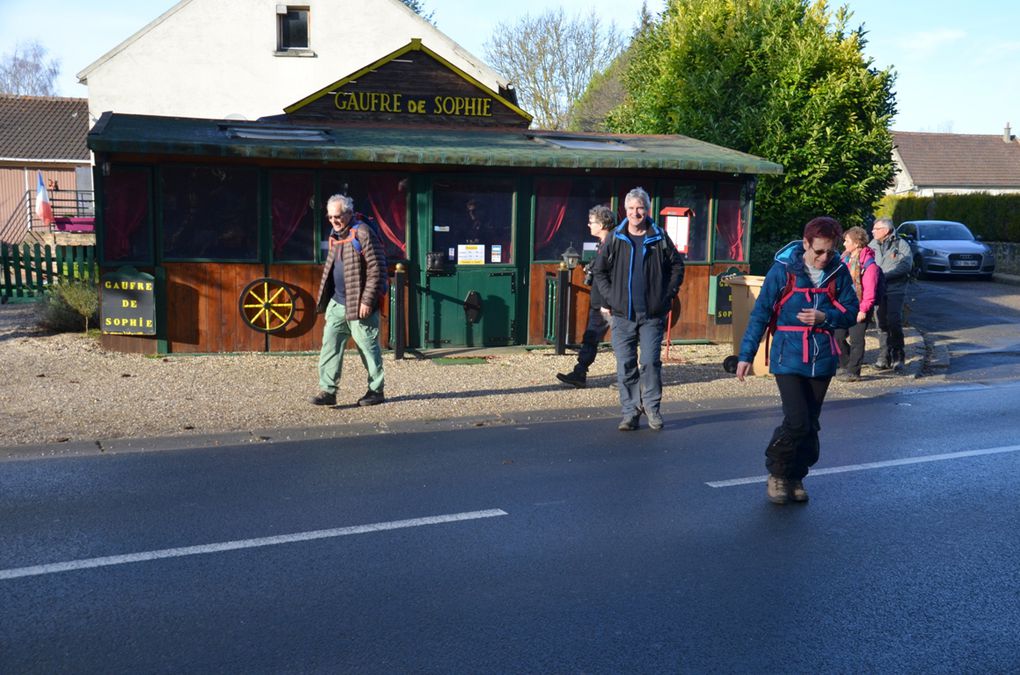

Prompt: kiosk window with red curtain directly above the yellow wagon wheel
xmin=269 ymin=171 xmax=317 ymax=262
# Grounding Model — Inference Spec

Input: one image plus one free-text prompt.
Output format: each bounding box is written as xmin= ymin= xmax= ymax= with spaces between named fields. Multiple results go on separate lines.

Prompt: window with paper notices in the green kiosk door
xmin=430 ymin=178 xmax=515 ymax=265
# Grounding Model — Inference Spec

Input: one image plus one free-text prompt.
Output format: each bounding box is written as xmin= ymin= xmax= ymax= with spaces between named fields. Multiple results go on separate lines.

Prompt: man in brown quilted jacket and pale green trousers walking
xmin=312 ymin=195 xmax=387 ymax=406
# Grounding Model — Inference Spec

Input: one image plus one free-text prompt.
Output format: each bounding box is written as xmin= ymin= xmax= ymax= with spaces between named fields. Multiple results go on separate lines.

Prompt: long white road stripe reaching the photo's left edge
xmin=0 ymin=509 xmax=509 ymax=580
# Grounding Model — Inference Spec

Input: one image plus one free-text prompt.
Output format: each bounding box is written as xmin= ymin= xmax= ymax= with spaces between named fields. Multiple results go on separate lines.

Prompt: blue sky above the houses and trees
xmin=0 ymin=0 xmax=1020 ymax=134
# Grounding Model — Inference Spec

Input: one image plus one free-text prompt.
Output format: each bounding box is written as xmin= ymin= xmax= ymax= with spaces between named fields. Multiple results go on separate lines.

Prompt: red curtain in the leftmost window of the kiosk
xmin=103 ymin=168 xmax=149 ymax=260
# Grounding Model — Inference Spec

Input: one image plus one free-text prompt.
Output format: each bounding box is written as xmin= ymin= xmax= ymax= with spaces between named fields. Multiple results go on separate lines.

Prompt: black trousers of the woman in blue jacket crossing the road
xmin=765 ymin=375 xmax=831 ymax=480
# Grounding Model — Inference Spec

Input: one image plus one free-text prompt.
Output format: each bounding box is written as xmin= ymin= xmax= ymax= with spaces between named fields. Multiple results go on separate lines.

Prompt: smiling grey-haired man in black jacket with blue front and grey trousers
xmin=594 ymin=188 xmax=683 ymax=431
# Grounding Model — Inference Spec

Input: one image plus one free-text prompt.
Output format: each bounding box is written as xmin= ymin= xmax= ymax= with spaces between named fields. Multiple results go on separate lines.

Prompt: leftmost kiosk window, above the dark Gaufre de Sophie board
xmin=103 ymin=164 xmax=152 ymax=264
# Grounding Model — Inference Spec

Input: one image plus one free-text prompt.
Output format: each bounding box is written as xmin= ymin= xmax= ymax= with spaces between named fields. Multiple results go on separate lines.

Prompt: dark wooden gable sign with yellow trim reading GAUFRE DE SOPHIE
xmin=284 ymin=38 xmax=531 ymax=128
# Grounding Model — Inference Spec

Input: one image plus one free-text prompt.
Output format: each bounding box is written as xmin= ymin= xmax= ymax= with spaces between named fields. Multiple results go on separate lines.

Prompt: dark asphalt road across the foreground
xmin=0 ymin=382 xmax=1020 ymax=673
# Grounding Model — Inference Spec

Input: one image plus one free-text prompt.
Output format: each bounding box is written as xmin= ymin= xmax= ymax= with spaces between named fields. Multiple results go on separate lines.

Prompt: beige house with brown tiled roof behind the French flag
xmin=0 ymin=94 xmax=93 ymax=244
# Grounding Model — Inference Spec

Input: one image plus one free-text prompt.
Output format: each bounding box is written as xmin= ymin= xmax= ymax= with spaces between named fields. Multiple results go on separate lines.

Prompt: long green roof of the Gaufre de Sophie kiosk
xmin=89 ymin=113 xmax=782 ymax=174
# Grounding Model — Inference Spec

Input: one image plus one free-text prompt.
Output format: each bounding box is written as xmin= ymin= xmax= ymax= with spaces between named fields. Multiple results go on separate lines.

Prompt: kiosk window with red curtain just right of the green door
xmin=532 ymin=177 xmax=613 ymax=262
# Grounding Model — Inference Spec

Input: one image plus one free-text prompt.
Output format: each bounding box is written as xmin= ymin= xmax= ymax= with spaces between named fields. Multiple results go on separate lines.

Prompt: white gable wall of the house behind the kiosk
xmin=79 ymin=0 xmax=500 ymax=122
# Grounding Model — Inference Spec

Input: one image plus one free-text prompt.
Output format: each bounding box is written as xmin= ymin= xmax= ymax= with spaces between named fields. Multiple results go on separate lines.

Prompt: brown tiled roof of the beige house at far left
xmin=0 ymin=94 xmax=89 ymax=161
